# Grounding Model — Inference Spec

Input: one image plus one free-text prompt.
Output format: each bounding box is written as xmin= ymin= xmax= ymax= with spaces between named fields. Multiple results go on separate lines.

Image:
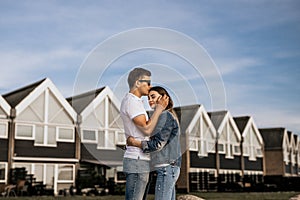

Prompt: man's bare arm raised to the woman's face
xmin=132 ymin=95 xmax=169 ymax=135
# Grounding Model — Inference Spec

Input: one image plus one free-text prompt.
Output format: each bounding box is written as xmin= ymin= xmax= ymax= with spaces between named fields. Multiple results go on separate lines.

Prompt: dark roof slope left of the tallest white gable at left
xmin=2 ymin=78 xmax=46 ymax=108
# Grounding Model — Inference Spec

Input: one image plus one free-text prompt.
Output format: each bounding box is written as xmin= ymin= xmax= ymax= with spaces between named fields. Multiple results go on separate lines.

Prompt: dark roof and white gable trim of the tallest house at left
xmin=3 ymin=78 xmax=77 ymax=122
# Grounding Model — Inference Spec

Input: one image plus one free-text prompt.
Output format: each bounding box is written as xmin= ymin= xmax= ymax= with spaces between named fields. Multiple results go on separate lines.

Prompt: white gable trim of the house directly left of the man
xmin=80 ymin=86 xmax=121 ymax=121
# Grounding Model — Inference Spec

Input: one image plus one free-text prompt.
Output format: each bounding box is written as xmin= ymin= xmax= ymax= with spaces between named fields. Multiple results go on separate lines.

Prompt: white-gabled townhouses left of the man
xmin=0 ymin=79 xmax=125 ymax=194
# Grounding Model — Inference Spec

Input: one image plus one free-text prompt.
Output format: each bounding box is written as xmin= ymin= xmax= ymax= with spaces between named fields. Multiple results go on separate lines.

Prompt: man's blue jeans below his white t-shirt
xmin=123 ymin=158 xmax=150 ymax=200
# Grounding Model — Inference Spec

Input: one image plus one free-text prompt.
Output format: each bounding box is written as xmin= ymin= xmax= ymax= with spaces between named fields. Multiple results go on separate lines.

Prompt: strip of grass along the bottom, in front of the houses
xmin=0 ymin=192 xmax=300 ymax=200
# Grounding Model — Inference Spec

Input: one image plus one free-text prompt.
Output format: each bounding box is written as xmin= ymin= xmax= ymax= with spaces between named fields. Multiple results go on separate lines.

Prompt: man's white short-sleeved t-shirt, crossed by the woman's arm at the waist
xmin=120 ymin=93 xmax=150 ymax=160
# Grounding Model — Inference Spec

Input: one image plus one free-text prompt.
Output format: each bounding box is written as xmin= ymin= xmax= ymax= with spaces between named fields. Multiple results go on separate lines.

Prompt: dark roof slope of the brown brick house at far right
xmin=259 ymin=128 xmax=288 ymax=150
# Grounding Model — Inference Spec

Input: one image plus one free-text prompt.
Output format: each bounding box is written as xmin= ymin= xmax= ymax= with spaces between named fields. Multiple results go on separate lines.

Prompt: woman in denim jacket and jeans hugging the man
xmin=127 ymin=86 xmax=181 ymax=200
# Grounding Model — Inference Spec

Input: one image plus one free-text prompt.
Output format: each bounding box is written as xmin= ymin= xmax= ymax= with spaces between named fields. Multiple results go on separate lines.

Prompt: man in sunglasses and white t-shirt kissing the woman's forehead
xmin=120 ymin=68 xmax=169 ymax=200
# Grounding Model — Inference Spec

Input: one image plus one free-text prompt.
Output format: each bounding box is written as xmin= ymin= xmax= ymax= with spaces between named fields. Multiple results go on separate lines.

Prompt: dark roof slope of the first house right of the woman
xmin=174 ymin=104 xmax=201 ymax=133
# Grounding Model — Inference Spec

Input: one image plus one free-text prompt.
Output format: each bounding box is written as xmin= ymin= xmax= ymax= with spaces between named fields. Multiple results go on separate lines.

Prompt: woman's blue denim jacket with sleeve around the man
xmin=142 ymin=111 xmax=181 ymax=167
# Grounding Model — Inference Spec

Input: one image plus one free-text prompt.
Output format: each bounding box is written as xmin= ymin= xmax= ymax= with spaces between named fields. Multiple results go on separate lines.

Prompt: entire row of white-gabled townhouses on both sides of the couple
xmin=0 ymin=79 xmax=300 ymax=194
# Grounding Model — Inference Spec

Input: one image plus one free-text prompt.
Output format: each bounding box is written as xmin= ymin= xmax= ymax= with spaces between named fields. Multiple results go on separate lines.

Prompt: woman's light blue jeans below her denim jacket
xmin=155 ymin=165 xmax=180 ymax=200
